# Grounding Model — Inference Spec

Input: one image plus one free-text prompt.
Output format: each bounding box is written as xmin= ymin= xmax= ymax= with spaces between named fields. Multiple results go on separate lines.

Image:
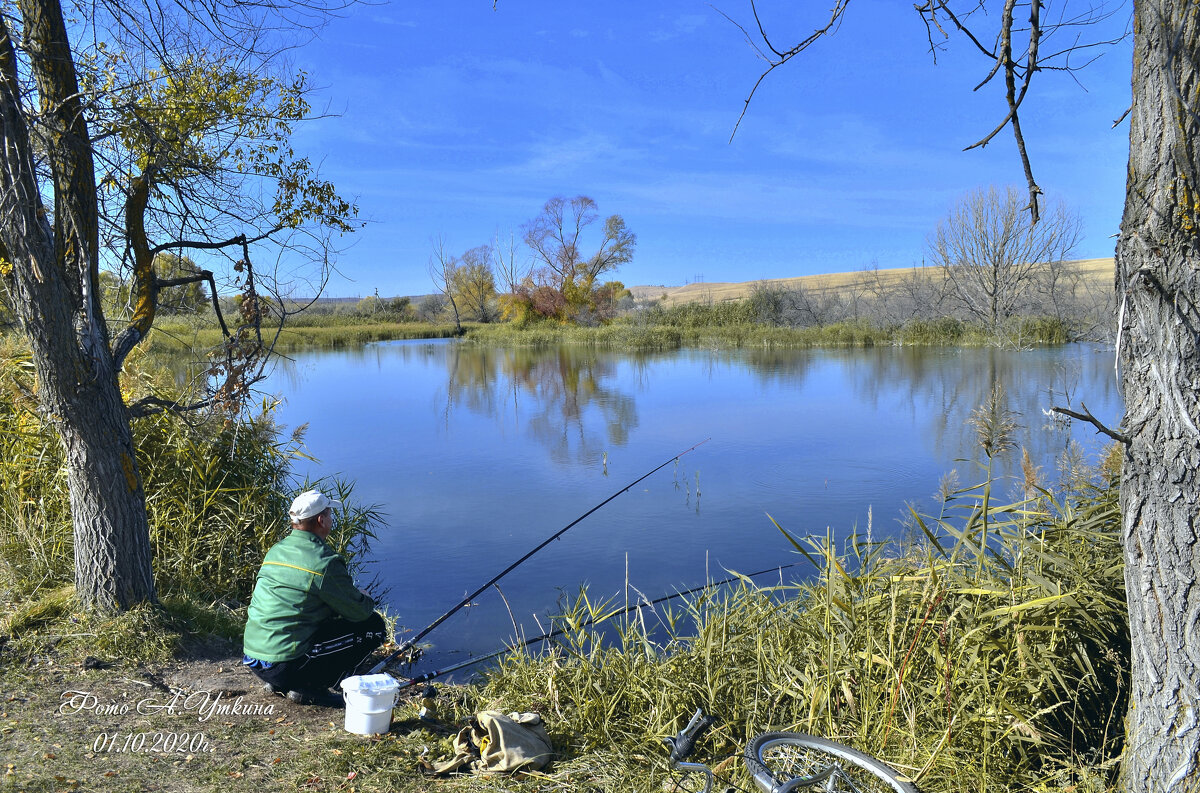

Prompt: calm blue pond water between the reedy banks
xmin=255 ymin=341 xmax=1121 ymax=671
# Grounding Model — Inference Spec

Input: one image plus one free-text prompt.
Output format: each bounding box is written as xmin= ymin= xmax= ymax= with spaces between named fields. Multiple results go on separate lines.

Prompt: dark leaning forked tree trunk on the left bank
xmin=0 ymin=0 xmax=155 ymax=608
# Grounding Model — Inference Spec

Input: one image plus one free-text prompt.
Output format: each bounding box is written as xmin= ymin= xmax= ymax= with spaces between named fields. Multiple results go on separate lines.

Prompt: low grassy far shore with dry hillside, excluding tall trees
xmin=126 ymin=259 xmax=1116 ymax=354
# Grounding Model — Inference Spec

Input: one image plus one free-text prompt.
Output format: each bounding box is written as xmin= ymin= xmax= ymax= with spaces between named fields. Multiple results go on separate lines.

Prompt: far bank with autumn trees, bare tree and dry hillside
xmin=319 ymin=187 xmax=1116 ymax=341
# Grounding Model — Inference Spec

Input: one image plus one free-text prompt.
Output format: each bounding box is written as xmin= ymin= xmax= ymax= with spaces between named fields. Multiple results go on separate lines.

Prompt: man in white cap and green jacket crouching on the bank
xmin=242 ymin=491 xmax=386 ymax=708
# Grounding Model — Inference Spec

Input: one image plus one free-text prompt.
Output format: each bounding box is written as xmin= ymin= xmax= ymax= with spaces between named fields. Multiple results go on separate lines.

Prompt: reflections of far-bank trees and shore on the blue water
xmin=260 ymin=342 xmax=1120 ymax=483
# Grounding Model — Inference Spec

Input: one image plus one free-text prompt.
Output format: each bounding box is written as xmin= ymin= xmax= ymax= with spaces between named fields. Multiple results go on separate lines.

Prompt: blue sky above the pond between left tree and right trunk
xmin=293 ymin=0 xmax=1130 ymax=296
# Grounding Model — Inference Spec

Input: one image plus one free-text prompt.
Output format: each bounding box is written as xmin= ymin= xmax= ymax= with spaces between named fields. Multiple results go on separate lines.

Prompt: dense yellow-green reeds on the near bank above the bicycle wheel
xmin=475 ymin=448 xmax=1129 ymax=793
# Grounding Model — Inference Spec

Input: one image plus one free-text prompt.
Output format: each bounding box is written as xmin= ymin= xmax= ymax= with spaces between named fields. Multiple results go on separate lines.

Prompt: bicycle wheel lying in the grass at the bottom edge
xmin=745 ymin=732 xmax=919 ymax=793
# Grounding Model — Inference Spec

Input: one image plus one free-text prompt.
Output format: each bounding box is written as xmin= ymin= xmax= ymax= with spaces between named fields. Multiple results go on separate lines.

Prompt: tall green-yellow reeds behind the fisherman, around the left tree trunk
xmin=0 ymin=341 xmax=380 ymax=605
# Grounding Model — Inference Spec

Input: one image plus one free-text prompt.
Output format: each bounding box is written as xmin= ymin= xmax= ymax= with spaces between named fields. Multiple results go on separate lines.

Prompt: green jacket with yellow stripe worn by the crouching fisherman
xmin=242 ymin=529 xmax=374 ymax=662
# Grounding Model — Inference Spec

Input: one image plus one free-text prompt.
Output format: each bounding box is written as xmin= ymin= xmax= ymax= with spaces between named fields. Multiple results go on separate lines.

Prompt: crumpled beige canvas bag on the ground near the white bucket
xmin=432 ymin=710 xmax=553 ymax=775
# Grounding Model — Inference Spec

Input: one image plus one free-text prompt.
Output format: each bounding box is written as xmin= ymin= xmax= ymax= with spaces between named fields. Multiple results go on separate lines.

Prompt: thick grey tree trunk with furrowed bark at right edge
xmin=1116 ymin=0 xmax=1200 ymax=793
